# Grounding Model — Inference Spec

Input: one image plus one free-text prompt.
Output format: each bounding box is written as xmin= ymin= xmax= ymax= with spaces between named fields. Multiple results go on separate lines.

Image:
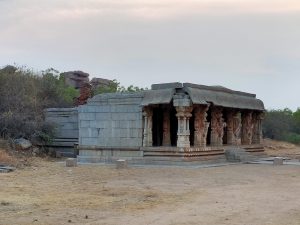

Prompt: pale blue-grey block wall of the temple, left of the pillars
xmin=78 ymin=93 xmax=143 ymax=148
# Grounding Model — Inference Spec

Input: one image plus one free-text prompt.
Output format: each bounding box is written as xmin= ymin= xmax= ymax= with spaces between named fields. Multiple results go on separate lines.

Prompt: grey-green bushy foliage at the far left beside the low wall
xmin=0 ymin=66 xmax=78 ymax=139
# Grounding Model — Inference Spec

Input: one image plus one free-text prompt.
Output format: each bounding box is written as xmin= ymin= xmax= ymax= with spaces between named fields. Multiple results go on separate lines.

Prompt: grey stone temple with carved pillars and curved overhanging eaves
xmin=48 ymin=83 xmax=264 ymax=162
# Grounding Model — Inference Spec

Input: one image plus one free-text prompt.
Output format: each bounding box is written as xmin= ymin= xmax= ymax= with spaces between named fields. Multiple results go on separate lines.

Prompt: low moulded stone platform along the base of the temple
xmin=77 ymin=145 xmax=264 ymax=164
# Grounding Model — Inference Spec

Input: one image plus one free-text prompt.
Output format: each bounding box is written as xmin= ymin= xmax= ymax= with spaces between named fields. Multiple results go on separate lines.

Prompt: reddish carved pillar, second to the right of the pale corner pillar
xmin=210 ymin=107 xmax=226 ymax=146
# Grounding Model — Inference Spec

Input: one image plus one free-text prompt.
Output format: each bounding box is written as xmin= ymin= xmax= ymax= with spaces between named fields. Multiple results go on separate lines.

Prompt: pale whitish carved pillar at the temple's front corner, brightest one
xmin=176 ymin=106 xmax=193 ymax=148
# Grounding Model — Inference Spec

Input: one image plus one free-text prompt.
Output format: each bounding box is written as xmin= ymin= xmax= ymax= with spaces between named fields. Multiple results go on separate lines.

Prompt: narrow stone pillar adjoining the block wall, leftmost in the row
xmin=143 ymin=107 xmax=153 ymax=147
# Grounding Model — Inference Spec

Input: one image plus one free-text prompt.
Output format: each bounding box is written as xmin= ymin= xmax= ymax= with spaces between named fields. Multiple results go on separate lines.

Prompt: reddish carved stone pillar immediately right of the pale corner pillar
xmin=194 ymin=105 xmax=209 ymax=147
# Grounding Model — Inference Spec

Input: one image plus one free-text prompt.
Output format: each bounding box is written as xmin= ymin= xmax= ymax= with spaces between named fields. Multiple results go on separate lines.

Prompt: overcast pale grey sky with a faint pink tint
xmin=0 ymin=0 xmax=300 ymax=110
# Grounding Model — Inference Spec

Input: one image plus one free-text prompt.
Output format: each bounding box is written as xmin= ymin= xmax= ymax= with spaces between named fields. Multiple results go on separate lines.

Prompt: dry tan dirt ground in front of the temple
xmin=0 ymin=141 xmax=300 ymax=225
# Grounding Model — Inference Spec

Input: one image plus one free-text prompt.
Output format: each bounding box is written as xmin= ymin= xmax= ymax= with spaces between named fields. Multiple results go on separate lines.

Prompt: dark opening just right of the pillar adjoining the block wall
xmin=152 ymin=107 xmax=163 ymax=146
